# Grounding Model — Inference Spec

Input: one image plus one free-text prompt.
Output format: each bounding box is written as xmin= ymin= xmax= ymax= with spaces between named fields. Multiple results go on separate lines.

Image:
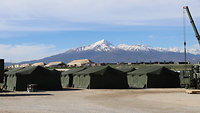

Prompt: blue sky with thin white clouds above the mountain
xmin=0 ymin=0 xmax=200 ymax=62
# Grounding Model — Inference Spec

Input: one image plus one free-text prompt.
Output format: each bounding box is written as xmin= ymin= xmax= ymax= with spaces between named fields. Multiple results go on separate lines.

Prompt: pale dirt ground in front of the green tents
xmin=0 ymin=88 xmax=200 ymax=113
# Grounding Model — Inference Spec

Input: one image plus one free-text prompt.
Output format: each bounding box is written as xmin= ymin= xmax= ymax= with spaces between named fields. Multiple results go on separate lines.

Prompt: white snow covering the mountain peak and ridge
xmin=71 ymin=39 xmax=200 ymax=55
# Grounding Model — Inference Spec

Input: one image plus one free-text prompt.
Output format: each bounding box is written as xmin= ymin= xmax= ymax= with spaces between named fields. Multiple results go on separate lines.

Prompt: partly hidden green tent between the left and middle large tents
xmin=61 ymin=68 xmax=86 ymax=87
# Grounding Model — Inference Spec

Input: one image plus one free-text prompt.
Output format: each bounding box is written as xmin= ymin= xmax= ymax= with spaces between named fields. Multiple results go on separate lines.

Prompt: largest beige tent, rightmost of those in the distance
xmin=67 ymin=59 xmax=94 ymax=67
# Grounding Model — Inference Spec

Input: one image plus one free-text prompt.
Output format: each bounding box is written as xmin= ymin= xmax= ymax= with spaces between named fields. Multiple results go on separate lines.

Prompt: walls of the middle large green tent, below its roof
xmin=73 ymin=74 xmax=128 ymax=89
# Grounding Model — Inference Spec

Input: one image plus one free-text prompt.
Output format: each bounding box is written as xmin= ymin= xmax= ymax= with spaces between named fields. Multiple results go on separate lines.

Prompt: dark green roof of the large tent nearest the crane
xmin=128 ymin=66 xmax=174 ymax=75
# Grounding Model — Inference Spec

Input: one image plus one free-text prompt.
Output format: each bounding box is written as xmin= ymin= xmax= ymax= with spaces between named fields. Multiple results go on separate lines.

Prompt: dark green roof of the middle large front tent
xmin=76 ymin=66 xmax=125 ymax=75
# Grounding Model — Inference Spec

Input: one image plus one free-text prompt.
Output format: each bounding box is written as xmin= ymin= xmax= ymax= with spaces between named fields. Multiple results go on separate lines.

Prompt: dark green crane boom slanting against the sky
xmin=183 ymin=6 xmax=200 ymax=45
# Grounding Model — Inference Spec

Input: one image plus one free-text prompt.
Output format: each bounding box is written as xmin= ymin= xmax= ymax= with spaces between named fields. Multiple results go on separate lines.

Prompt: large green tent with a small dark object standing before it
xmin=6 ymin=66 xmax=62 ymax=91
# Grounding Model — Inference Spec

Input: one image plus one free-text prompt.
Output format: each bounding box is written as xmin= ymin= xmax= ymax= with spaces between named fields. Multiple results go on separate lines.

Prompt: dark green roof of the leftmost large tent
xmin=15 ymin=66 xmax=51 ymax=75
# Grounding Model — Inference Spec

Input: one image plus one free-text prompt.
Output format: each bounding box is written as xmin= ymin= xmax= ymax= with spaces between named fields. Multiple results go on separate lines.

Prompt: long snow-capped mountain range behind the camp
xmin=18 ymin=39 xmax=200 ymax=64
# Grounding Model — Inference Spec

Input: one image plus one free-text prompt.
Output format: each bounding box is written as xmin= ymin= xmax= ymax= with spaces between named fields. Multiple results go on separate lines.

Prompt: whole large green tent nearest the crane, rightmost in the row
xmin=127 ymin=66 xmax=180 ymax=88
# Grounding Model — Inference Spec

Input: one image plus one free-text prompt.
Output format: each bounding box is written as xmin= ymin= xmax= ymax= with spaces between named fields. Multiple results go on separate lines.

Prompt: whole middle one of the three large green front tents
xmin=73 ymin=66 xmax=128 ymax=89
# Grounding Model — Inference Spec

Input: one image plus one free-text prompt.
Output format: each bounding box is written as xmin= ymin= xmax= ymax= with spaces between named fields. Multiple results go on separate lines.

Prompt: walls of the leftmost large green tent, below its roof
xmin=6 ymin=73 xmax=62 ymax=91
